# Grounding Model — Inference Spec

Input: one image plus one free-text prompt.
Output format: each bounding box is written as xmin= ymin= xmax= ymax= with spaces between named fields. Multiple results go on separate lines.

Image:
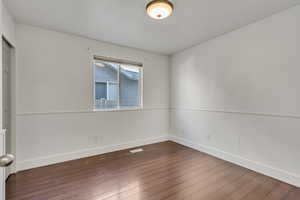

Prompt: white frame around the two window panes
xmin=92 ymin=55 xmax=144 ymax=112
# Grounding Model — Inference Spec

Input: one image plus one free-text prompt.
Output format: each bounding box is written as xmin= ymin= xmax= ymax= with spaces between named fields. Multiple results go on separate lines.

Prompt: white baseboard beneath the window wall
xmin=16 ymin=135 xmax=169 ymax=171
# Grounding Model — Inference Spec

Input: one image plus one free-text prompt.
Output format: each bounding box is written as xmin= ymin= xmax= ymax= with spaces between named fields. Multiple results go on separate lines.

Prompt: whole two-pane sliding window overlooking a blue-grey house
xmin=94 ymin=56 xmax=143 ymax=110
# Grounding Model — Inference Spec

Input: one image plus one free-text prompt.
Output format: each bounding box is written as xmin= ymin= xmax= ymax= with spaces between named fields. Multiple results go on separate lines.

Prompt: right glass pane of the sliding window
xmin=120 ymin=65 xmax=141 ymax=107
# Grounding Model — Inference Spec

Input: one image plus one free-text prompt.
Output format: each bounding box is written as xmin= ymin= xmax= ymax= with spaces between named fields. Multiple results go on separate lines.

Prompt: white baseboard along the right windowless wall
xmin=170 ymin=135 xmax=300 ymax=187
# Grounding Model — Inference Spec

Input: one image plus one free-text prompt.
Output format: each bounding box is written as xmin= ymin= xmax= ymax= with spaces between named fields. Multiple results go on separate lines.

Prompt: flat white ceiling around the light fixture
xmin=4 ymin=0 xmax=299 ymax=54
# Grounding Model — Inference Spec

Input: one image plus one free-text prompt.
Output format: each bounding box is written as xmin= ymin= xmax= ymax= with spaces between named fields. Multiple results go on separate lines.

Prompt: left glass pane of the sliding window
xmin=94 ymin=60 xmax=119 ymax=109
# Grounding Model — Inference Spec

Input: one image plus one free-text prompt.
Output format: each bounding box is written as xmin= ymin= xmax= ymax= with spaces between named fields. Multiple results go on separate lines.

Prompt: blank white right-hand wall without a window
xmin=171 ymin=6 xmax=300 ymax=186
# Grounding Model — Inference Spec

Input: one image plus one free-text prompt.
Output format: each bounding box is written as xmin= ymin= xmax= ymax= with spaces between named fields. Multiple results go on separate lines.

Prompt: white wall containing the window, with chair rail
xmin=17 ymin=25 xmax=170 ymax=170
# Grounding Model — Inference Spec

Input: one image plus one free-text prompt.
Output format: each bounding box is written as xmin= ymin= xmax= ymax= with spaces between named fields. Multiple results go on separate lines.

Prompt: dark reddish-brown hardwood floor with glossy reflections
xmin=7 ymin=142 xmax=300 ymax=200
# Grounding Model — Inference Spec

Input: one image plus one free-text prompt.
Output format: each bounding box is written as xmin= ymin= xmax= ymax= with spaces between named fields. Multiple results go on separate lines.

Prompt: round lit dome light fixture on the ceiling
xmin=146 ymin=0 xmax=174 ymax=19
